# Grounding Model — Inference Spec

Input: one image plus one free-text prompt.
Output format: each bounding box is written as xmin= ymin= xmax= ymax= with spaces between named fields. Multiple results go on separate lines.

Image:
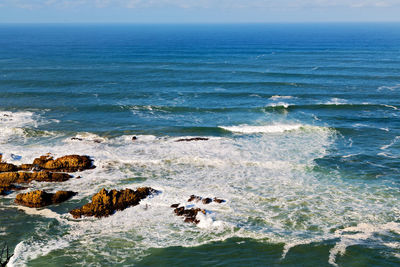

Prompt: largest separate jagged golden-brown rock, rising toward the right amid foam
xmin=70 ymin=187 xmax=157 ymax=218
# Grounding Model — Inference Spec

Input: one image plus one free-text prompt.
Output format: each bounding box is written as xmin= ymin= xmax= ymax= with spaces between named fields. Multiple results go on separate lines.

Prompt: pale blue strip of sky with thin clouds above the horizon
xmin=0 ymin=0 xmax=400 ymax=23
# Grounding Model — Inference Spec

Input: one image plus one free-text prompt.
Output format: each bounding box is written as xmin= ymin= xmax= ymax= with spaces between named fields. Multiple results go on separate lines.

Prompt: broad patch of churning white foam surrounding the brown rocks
xmin=0 ymin=124 xmax=397 ymax=266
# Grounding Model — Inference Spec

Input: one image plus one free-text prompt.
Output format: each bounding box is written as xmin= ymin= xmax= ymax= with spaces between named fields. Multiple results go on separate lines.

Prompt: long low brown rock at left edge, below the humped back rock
xmin=0 ymin=171 xmax=72 ymax=184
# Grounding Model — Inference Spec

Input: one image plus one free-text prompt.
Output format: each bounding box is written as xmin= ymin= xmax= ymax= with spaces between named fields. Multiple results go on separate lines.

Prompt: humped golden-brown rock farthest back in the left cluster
xmin=33 ymin=155 xmax=95 ymax=172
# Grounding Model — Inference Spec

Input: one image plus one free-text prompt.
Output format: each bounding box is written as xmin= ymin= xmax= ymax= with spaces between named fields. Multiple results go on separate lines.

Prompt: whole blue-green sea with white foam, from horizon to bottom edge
xmin=0 ymin=24 xmax=400 ymax=266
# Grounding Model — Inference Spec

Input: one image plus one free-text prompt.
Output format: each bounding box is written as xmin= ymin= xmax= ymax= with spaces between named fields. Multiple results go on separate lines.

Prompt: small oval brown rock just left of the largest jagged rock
xmin=15 ymin=190 xmax=77 ymax=208
